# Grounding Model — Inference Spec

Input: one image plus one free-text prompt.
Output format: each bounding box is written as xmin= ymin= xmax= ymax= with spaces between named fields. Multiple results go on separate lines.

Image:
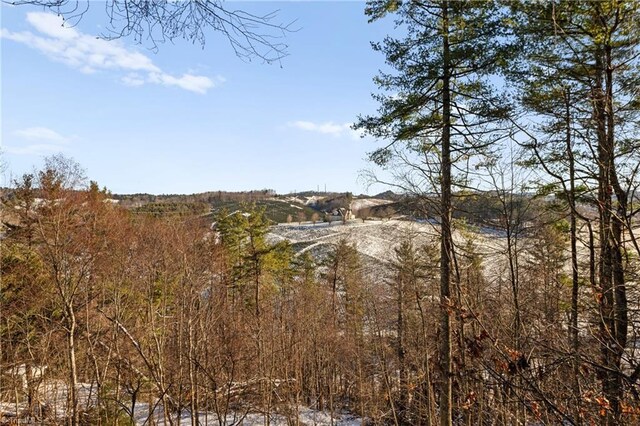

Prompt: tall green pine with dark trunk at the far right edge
xmin=517 ymin=0 xmax=640 ymax=424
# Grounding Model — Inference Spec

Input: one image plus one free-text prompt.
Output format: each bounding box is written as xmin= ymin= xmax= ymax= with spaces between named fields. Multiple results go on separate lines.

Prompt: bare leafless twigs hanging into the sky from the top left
xmin=2 ymin=0 xmax=293 ymax=63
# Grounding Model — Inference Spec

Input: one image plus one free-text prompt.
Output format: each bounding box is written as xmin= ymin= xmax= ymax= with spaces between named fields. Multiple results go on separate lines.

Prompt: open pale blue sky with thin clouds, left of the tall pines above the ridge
xmin=0 ymin=1 xmax=393 ymax=194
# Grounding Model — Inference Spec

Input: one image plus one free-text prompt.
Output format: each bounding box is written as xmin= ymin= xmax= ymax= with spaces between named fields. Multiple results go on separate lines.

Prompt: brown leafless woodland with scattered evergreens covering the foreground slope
xmin=0 ymin=151 xmax=638 ymax=424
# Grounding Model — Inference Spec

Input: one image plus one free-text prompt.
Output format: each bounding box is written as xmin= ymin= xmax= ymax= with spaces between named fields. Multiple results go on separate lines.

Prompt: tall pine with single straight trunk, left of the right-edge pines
xmin=356 ymin=0 xmax=509 ymax=425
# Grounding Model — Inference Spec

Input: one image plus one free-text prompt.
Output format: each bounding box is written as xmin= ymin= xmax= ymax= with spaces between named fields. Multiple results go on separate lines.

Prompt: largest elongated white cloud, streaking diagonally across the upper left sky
xmin=0 ymin=12 xmax=224 ymax=94
